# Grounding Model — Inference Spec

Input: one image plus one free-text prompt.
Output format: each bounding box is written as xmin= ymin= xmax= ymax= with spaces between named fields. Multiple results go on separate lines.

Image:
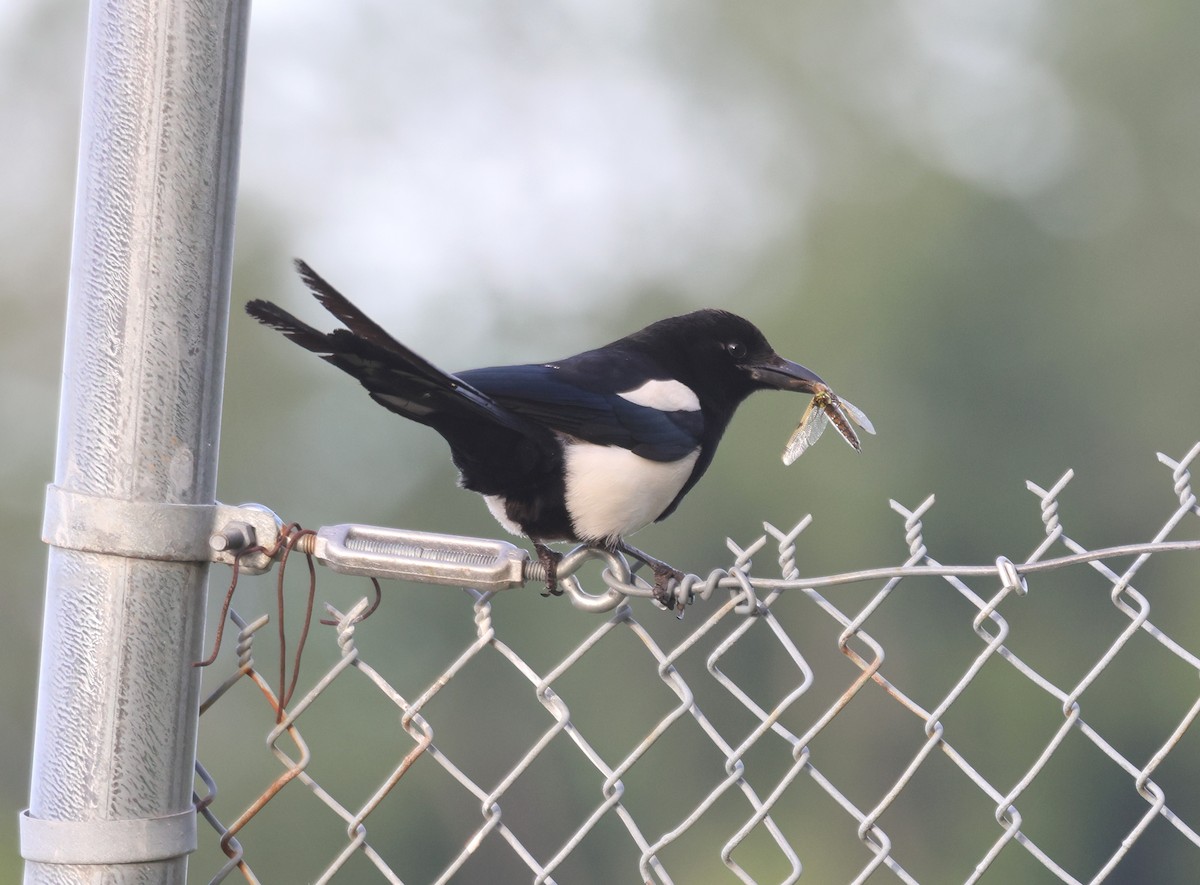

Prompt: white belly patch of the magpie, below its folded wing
xmin=564 ymin=443 xmax=700 ymax=542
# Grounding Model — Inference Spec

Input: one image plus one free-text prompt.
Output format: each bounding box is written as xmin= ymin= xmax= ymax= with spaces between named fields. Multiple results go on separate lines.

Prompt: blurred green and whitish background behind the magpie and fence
xmin=0 ymin=0 xmax=1200 ymax=881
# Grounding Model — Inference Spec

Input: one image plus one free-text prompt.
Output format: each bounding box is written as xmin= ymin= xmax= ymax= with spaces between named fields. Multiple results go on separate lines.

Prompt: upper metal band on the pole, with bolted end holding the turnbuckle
xmin=42 ymin=486 xmax=282 ymax=574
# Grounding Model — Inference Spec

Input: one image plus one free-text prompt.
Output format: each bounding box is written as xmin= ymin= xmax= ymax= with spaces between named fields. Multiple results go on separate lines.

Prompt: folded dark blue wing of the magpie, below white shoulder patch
xmin=457 ymin=365 xmax=703 ymax=462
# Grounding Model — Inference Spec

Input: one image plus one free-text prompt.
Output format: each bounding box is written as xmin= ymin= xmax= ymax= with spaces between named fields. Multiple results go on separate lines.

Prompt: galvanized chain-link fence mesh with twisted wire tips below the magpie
xmin=192 ymin=444 xmax=1200 ymax=884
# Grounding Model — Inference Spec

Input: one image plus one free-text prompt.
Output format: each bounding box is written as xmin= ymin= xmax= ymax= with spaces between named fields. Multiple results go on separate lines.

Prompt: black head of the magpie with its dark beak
xmin=628 ymin=309 xmax=824 ymax=413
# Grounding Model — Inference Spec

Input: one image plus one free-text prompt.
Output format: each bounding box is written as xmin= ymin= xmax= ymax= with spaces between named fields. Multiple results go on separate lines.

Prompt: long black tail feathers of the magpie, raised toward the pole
xmin=246 ymin=259 xmax=529 ymax=436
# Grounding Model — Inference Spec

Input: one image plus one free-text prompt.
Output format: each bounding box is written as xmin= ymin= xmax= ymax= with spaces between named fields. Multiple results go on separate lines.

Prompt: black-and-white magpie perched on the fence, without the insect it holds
xmin=246 ymin=260 xmax=828 ymax=604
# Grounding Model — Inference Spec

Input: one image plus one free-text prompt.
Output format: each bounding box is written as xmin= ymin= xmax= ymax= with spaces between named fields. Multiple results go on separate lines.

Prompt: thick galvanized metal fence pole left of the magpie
xmin=22 ymin=0 xmax=248 ymax=883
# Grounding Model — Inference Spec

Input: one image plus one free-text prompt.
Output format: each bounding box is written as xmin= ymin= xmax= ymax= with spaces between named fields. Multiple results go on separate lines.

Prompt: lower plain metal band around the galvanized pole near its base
xmin=20 ymin=808 xmax=196 ymax=865
